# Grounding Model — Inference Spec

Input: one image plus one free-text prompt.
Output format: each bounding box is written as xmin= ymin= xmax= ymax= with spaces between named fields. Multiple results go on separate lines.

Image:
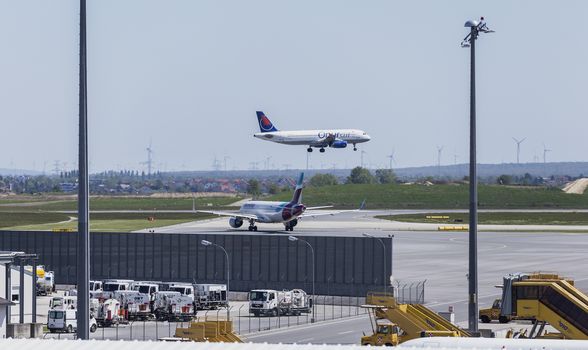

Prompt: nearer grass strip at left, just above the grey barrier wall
xmin=0 ymin=212 xmax=216 ymax=232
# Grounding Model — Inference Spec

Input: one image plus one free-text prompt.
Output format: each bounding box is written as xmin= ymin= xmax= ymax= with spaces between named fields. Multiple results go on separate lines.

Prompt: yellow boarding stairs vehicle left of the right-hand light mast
xmin=361 ymin=293 xmax=470 ymax=346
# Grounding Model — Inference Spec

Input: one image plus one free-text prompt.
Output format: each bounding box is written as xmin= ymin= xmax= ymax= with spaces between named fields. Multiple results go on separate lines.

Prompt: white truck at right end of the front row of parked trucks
xmin=153 ymin=291 xmax=194 ymax=321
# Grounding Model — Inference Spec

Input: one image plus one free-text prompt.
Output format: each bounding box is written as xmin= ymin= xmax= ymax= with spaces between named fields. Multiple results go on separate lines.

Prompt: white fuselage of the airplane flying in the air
xmin=253 ymin=129 xmax=370 ymax=147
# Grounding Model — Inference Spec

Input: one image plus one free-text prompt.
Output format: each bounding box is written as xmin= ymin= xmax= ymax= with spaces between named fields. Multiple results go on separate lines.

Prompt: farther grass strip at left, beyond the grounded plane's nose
xmin=0 ymin=197 xmax=241 ymax=211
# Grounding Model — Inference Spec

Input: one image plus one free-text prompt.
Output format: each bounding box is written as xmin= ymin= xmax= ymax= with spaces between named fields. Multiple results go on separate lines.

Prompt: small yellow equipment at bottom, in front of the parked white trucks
xmin=175 ymin=320 xmax=243 ymax=343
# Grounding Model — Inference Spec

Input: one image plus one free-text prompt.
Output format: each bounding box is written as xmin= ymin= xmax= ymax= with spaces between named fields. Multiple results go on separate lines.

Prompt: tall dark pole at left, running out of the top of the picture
xmin=77 ymin=0 xmax=90 ymax=340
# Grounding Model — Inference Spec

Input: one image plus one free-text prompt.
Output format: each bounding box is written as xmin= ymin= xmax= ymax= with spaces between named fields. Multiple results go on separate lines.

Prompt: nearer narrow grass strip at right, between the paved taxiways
xmin=377 ymin=212 xmax=588 ymax=225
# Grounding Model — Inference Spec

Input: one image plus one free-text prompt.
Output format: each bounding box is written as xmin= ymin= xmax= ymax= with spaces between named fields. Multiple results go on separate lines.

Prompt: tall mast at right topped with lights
xmin=468 ymin=26 xmax=478 ymax=332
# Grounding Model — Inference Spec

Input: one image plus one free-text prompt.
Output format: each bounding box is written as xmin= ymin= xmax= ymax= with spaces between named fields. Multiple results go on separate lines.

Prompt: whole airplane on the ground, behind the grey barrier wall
xmin=198 ymin=173 xmax=365 ymax=231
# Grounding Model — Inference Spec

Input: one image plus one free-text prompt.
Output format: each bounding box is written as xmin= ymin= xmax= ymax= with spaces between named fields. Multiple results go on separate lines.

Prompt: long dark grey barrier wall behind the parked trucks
xmin=0 ymin=231 xmax=391 ymax=296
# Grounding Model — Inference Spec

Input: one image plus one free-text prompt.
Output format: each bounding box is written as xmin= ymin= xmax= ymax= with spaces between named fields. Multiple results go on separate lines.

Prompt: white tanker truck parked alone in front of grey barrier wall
xmin=249 ymin=289 xmax=312 ymax=316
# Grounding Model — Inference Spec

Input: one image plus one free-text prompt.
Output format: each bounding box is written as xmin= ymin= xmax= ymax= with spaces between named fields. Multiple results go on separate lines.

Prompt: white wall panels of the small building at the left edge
xmin=0 ymin=264 xmax=33 ymax=323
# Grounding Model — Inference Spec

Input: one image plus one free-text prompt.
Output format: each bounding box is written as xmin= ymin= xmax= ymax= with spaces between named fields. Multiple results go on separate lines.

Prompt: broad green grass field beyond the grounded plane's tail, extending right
xmin=268 ymin=184 xmax=588 ymax=209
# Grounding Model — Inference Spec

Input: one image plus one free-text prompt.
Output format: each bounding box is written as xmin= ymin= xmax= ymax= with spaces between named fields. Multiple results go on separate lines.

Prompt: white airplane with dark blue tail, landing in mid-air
xmin=253 ymin=111 xmax=371 ymax=153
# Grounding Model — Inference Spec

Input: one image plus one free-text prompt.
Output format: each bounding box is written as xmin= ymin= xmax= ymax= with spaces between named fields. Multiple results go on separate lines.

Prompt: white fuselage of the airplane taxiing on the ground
xmin=239 ymin=201 xmax=306 ymax=223
